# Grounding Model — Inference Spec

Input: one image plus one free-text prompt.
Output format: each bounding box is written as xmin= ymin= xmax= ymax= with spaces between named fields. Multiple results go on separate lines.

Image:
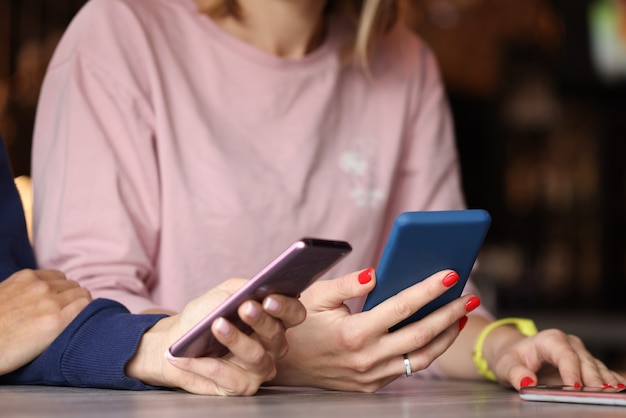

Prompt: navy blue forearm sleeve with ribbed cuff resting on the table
xmin=0 ymin=299 xmax=166 ymax=390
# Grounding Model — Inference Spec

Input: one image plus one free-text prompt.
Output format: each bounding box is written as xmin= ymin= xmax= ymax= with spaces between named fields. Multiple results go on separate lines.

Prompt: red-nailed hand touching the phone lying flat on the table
xmin=485 ymin=327 xmax=626 ymax=390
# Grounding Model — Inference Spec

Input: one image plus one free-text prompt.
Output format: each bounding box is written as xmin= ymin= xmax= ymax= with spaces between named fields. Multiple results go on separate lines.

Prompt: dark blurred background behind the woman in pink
xmin=0 ymin=0 xmax=626 ymax=370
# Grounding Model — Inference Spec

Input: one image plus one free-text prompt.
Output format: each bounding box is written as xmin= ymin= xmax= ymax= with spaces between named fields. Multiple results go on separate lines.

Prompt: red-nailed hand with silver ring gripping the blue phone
xmin=271 ymin=269 xmax=480 ymax=392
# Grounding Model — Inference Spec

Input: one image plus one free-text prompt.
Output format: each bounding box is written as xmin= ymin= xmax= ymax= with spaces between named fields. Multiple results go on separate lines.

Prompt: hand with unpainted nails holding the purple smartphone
xmin=126 ymin=279 xmax=306 ymax=396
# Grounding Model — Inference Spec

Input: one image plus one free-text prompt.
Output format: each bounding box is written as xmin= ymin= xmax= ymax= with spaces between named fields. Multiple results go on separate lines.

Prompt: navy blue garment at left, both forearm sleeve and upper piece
xmin=0 ymin=138 xmax=165 ymax=390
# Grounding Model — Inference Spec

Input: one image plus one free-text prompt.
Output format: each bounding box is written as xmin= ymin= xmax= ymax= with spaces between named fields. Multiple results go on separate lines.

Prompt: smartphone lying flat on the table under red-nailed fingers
xmin=520 ymin=386 xmax=626 ymax=406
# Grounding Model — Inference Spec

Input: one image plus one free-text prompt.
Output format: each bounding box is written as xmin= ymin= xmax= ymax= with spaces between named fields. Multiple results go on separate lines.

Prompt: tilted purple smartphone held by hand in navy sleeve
xmin=169 ymin=238 xmax=352 ymax=357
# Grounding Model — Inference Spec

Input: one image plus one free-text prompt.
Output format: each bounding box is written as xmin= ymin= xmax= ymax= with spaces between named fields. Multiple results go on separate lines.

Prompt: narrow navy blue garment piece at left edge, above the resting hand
xmin=0 ymin=137 xmax=35 ymax=281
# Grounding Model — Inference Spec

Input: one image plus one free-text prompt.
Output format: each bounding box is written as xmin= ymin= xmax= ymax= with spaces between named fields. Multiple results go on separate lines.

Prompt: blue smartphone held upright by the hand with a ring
xmin=363 ymin=209 xmax=491 ymax=331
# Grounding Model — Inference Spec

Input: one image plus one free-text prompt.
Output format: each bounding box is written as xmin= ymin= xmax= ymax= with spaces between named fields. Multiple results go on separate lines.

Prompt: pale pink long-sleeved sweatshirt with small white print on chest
xmin=33 ymin=0 xmax=488 ymax=332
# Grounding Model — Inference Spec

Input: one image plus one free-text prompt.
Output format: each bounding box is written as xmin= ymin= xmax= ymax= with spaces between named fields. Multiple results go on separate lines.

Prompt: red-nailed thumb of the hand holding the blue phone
xmin=301 ymin=267 xmax=376 ymax=312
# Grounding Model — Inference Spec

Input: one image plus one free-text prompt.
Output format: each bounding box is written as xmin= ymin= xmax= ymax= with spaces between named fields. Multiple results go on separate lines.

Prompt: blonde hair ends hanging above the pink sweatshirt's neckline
xmin=196 ymin=0 xmax=402 ymax=70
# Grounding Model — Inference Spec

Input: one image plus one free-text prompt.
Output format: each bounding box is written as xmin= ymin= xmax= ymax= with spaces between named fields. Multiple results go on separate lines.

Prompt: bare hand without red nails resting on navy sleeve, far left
xmin=0 ymin=269 xmax=91 ymax=375
